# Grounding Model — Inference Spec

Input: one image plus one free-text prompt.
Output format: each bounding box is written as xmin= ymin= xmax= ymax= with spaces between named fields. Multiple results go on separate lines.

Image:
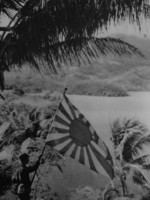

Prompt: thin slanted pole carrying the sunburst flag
xmin=31 ymin=88 xmax=67 ymax=186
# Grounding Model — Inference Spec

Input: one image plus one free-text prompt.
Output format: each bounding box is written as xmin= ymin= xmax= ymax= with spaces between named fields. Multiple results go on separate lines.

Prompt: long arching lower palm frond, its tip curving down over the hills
xmin=1 ymin=34 xmax=144 ymax=74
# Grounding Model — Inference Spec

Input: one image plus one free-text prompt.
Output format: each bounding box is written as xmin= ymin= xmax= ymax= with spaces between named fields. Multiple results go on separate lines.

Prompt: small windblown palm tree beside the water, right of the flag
xmin=111 ymin=119 xmax=150 ymax=194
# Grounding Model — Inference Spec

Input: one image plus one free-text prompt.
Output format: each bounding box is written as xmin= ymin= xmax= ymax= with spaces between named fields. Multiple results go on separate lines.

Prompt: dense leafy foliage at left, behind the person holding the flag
xmin=0 ymin=97 xmax=64 ymax=198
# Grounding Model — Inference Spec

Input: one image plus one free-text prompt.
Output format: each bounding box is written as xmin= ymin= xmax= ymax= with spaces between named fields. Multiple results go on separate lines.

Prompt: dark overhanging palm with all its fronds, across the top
xmin=0 ymin=0 xmax=148 ymax=90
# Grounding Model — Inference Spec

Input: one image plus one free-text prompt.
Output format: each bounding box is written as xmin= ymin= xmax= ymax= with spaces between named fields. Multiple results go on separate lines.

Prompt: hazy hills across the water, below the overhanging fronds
xmin=2 ymin=34 xmax=150 ymax=96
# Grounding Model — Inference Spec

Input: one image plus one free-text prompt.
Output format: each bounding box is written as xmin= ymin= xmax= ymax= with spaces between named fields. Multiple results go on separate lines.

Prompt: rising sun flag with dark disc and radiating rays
xmin=46 ymin=91 xmax=114 ymax=179
